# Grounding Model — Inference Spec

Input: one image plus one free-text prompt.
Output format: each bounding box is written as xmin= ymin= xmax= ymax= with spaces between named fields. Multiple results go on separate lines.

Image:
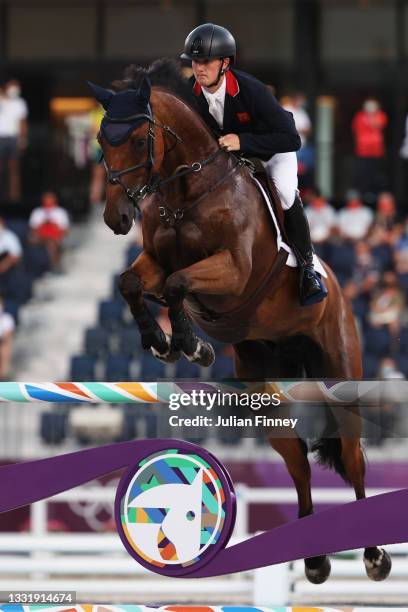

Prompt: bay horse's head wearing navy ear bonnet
xmin=89 ymin=77 xmax=164 ymax=234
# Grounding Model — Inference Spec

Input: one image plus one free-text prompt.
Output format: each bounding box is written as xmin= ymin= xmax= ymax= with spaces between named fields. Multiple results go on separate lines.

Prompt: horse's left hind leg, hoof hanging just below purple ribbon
xmin=234 ymin=340 xmax=331 ymax=584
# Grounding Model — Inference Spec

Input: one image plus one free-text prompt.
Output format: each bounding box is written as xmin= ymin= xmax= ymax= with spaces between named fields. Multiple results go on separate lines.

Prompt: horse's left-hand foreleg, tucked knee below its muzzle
xmin=119 ymin=251 xmax=181 ymax=362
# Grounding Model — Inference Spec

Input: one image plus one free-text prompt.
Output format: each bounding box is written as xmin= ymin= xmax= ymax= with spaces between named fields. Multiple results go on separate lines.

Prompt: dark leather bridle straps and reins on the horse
xmin=102 ymin=106 xmax=239 ymax=226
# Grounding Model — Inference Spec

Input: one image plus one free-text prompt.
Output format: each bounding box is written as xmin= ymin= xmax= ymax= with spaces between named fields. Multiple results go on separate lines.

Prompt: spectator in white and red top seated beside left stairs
xmin=28 ymin=191 xmax=69 ymax=270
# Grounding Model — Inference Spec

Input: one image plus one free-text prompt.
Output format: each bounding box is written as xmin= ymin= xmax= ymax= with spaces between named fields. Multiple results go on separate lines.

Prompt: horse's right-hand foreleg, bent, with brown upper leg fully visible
xmin=163 ymin=251 xmax=250 ymax=367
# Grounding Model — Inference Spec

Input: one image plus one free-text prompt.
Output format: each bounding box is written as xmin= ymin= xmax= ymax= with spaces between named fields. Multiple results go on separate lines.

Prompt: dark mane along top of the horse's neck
xmin=112 ymin=58 xmax=192 ymax=103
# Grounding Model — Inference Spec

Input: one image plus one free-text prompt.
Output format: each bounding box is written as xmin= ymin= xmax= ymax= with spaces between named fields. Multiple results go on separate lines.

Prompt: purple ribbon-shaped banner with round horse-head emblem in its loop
xmin=0 ymin=439 xmax=408 ymax=578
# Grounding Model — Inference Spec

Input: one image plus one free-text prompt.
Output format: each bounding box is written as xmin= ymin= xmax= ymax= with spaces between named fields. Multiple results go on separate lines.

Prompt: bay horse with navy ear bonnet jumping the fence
xmin=90 ymin=60 xmax=391 ymax=584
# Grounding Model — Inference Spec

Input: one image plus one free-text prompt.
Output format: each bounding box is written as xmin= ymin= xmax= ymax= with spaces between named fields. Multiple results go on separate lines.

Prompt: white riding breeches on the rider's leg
xmin=264 ymin=151 xmax=298 ymax=210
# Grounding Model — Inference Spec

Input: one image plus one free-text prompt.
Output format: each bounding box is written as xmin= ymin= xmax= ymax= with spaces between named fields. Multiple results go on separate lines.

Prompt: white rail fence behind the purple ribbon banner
xmin=0 ymin=484 xmax=408 ymax=606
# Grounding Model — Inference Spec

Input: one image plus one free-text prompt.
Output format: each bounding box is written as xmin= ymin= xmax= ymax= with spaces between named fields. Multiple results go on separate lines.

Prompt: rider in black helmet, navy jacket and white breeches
xmin=180 ymin=23 xmax=327 ymax=306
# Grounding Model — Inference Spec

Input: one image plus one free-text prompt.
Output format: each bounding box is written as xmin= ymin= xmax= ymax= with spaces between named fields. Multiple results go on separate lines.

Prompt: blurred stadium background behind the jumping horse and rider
xmin=0 ymin=0 xmax=408 ymax=605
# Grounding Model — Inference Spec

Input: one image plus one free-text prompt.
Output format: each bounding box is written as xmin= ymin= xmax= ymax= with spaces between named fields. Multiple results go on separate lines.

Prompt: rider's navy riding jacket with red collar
xmin=191 ymin=70 xmax=301 ymax=161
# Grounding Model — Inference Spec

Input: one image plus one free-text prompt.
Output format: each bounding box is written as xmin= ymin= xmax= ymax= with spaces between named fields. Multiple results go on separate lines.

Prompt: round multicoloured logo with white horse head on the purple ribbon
xmin=116 ymin=445 xmax=235 ymax=576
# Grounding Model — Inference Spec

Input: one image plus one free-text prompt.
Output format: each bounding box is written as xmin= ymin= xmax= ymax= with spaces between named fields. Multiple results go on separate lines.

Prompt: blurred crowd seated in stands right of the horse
xmin=306 ymin=192 xmax=408 ymax=378
